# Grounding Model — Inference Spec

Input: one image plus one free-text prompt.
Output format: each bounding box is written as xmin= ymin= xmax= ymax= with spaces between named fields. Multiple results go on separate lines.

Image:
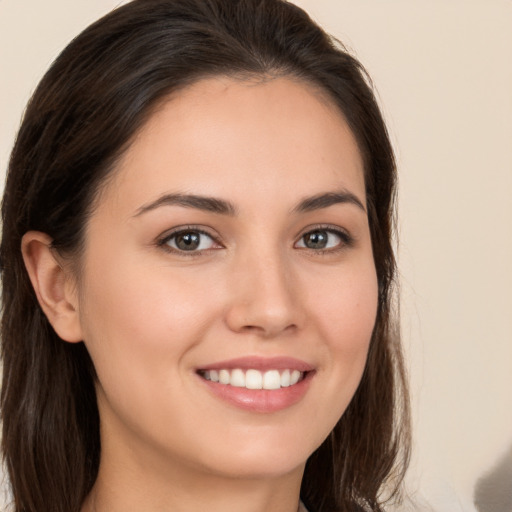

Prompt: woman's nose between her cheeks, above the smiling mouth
xmin=226 ymin=249 xmax=304 ymax=338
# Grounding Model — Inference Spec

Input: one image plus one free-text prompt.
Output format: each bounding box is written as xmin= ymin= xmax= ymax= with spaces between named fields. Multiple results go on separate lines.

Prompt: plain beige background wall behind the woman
xmin=0 ymin=0 xmax=512 ymax=512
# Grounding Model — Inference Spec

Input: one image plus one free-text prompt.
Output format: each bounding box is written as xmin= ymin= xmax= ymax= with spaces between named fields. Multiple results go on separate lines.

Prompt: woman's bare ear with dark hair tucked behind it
xmin=21 ymin=231 xmax=83 ymax=343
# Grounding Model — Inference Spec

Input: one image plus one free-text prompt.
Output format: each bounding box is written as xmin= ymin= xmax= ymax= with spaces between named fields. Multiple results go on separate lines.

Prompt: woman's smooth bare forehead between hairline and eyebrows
xmin=100 ymin=77 xmax=365 ymax=215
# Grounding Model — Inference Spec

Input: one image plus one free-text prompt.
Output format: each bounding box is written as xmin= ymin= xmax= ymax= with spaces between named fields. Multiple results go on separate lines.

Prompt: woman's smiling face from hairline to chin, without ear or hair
xmin=78 ymin=78 xmax=377 ymax=476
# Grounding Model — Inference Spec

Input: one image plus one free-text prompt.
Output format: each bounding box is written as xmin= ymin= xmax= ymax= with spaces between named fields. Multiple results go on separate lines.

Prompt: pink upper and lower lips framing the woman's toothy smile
xmin=196 ymin=357 xmax=316 ymax=414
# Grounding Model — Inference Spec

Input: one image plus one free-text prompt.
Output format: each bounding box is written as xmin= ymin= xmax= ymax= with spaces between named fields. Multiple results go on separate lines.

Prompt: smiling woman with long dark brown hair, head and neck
xmin=1 ymin=0 xmax=408 ymax=512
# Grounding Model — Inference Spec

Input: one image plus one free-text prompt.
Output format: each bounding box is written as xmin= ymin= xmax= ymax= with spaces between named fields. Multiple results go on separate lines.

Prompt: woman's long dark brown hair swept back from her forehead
xmin=0 ymin=0 xmax=409 ymax=512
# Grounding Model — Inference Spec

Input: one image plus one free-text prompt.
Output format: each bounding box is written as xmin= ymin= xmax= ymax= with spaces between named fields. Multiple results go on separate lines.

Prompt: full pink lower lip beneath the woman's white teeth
xmin=198 ymin=371 xmax=315 ymax=413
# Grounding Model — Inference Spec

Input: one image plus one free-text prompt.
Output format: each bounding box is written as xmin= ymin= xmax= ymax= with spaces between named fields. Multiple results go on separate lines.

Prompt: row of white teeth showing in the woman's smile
xmin=202 ymin=368 xmax=304 ymax=389
